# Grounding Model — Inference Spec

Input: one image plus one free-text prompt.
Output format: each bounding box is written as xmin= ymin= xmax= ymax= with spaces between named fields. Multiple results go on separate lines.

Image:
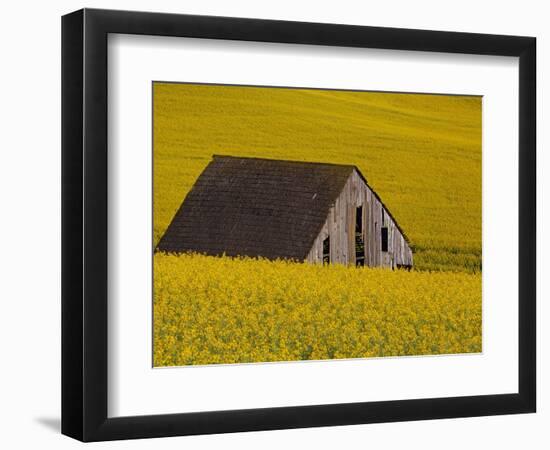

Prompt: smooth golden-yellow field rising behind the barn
xmin=154 ymin=83 xmax=481 ymax=272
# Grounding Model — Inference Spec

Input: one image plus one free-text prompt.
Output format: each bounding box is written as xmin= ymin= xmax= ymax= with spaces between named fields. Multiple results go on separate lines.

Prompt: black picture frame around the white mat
xmin=62 ymin=9 xmax=536 ymax=441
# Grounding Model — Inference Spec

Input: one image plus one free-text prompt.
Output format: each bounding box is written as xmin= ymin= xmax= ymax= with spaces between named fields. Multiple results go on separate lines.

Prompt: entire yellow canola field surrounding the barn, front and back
xmin=153 ymin=83 xmax=481 ymax=366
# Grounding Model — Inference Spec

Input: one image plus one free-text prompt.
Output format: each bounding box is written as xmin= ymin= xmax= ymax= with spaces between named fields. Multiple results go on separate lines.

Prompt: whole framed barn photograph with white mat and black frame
xmin=62 ymin=9 xmax=536 ymax=441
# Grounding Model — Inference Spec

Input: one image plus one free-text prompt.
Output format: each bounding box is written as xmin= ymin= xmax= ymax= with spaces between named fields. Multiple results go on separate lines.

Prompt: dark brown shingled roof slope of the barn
xmin=157 ymin=155 xmax=355 ymax=260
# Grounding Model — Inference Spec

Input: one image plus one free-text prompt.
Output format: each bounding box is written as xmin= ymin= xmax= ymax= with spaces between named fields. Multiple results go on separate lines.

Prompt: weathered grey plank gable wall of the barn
xmin=306 ymin=170 xmax=413 ymax=268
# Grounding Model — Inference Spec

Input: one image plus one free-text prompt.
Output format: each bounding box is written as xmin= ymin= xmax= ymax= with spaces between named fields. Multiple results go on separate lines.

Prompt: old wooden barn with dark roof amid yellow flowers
xmin=157 ymin=155 xmax=413 ymax=269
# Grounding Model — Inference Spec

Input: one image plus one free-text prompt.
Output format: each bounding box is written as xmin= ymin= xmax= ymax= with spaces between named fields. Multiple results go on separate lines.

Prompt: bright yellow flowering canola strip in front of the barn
xmin=154 ymin=254 xmax=481 ymax=366
